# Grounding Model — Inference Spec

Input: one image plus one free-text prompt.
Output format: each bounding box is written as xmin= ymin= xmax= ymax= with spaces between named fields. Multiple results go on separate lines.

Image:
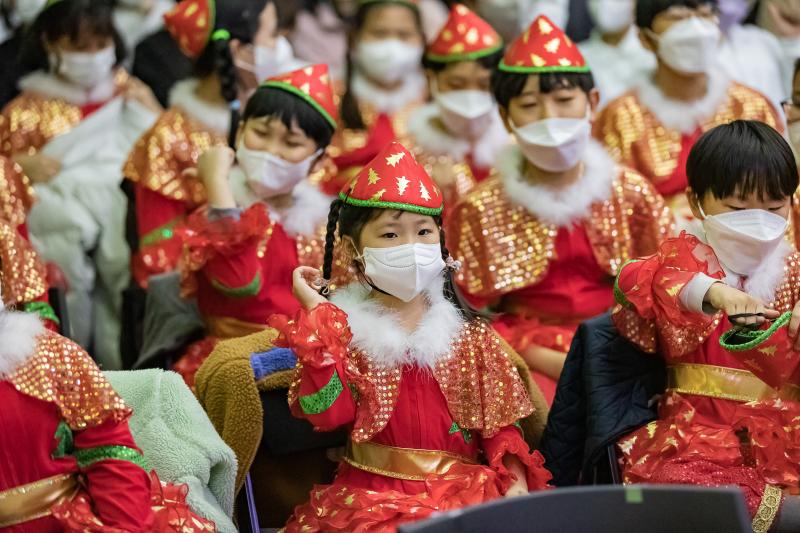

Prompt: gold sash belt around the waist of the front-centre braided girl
xmin=344 ymin=442 xmax=476 ymax=481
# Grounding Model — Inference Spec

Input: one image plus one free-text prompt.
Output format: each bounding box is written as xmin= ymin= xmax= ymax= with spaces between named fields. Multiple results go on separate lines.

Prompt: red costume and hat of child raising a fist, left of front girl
xmin=176 ymin=65 xmax=337 ymax=385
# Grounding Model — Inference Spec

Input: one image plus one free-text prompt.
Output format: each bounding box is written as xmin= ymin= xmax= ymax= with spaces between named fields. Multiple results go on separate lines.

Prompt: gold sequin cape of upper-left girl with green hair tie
xmin=123 ymin=107 xmax=226 ymax=207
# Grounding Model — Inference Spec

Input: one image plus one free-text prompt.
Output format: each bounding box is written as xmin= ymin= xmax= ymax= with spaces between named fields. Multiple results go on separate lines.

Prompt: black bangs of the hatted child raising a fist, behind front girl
xmin=242 ymin=86 xmax=333 ymax=149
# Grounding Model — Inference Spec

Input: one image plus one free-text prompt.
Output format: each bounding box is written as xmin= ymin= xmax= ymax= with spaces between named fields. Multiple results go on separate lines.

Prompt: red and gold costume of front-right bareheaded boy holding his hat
xmin=614 ymin=233 xmax=800 ymax=533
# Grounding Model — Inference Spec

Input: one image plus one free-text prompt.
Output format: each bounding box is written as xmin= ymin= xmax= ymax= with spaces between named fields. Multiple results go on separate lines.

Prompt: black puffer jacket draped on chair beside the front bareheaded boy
xmin=540 ymin=313 xmax=665 ymax=486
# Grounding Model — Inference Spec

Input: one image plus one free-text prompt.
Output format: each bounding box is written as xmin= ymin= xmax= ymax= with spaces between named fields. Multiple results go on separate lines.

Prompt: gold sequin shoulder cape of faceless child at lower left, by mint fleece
xmin=9 ymin=332 xmax=131 ymax=431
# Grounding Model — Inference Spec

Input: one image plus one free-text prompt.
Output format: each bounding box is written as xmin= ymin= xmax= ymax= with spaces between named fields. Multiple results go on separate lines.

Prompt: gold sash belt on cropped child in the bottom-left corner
xmin=0 ymin=474 xmax=80 ymax=528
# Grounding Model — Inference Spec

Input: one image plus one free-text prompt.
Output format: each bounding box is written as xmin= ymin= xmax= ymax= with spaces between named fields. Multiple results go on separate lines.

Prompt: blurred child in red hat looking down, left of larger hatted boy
xmin=406 ymin=4 xmax=510 ymax=205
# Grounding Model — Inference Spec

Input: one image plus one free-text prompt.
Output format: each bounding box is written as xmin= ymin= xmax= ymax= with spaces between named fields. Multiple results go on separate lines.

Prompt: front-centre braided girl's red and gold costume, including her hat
xmin=270 ymin=143 xmax=550 ymax=532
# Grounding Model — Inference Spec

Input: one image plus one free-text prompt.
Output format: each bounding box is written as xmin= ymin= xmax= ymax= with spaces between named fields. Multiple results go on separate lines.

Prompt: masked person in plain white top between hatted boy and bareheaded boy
xmin=580 ymin=0 xmax=656 ymax=107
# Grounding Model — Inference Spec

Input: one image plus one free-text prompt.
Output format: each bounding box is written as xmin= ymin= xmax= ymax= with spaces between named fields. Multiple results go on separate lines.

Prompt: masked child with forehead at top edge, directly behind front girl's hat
xmin=324 ymin=0 xmax=427 ymax=194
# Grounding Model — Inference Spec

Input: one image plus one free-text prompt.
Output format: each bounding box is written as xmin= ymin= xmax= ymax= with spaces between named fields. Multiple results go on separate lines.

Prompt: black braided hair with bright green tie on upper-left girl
xmin=195 ymin=0 xmax=272 ymax=146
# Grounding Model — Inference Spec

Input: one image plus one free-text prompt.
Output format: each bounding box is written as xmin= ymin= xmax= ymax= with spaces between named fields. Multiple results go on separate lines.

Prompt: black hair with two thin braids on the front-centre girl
xmin=320 ymin=198 xmax=483 ymax=320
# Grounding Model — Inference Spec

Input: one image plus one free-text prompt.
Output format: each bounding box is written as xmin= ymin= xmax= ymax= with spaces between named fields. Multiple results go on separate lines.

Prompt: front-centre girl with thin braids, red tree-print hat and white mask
xmin=269 ymin=143 xmax=550 ymax=533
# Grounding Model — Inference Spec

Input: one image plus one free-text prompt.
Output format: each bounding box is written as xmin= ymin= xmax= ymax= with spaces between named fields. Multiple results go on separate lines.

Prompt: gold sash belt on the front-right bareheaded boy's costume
xmin=667 ymin=363 xmax=800 ymax=402
